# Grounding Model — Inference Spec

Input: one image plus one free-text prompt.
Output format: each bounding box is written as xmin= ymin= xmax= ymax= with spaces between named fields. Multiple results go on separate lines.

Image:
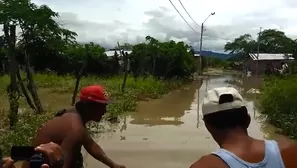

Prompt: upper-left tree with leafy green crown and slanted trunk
xmin=0 ymin=0 xmax=76 ymax=113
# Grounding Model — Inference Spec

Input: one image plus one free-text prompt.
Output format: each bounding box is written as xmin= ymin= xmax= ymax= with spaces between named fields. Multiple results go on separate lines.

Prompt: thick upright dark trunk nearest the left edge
xmin=3 ymin=23 xmax=20 ymax=129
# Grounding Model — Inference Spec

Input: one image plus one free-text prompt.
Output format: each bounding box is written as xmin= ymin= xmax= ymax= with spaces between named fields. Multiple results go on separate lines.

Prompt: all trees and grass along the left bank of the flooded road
xmin=0 ymin=0 xmax=196 ymax=154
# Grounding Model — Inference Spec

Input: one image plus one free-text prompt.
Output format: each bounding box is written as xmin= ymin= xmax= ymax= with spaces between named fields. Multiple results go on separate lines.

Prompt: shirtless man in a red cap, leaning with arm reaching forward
xmin=25 ymin=85 xmax=125 ymax=168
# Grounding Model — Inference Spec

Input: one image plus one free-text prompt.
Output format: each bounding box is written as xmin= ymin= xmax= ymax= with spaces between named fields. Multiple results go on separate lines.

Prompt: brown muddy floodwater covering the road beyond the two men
xmin=84 ymin=75 xmax=273 ymax=168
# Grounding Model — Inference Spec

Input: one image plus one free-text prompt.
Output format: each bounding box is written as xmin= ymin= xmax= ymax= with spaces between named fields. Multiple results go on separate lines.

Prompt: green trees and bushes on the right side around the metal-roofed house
xmin=225 ymin=29 xmax=297 ymax=140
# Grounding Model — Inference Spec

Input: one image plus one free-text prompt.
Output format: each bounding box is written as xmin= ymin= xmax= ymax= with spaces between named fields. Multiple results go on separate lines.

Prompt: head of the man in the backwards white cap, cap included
xmin=202 ymin=87 xmax=251 ymax=143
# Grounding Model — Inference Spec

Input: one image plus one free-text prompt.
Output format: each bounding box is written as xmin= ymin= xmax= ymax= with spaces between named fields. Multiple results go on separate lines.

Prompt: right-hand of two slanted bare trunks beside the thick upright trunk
xmin=25 ymin=50 xmax=44 ymax=114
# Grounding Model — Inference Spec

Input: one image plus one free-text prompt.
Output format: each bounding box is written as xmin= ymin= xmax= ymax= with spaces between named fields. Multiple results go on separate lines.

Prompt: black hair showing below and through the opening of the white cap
xmin=204 ymin=94 xmax=250 ymax=130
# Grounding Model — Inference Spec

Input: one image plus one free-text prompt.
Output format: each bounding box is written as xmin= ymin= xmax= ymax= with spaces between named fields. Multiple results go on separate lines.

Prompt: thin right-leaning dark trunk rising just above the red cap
xmin=71 ymin=44 xmax=90 ymax=106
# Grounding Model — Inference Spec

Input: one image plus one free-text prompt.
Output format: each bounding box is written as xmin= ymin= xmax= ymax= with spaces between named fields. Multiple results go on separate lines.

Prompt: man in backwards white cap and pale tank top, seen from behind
xmin=190 ymin=87 xmax=297 ymax=168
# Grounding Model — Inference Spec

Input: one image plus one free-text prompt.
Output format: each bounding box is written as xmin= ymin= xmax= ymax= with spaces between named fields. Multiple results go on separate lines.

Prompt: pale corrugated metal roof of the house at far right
xmin=249 ymin=53 xmax=294 ymax=60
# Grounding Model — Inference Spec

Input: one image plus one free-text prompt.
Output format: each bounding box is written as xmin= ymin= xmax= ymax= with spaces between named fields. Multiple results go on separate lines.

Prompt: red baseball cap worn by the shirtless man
xmin=79 ymin=85 xmax=110 ymax=104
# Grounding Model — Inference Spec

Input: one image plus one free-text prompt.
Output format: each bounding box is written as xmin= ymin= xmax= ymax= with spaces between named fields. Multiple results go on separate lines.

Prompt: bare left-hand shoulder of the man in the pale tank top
xmin=190 ymin=154 xmax=226 ymax=168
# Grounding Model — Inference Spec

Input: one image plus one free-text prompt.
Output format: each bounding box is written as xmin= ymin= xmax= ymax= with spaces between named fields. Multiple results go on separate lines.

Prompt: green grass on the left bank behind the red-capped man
xmin=0 ymin=74 xmax=185 ymax=154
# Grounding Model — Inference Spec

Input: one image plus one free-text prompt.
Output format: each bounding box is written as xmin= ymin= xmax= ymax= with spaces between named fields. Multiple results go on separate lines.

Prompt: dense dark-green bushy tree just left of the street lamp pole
xmin=130 ymin=36 xmax=196 ymax=78
